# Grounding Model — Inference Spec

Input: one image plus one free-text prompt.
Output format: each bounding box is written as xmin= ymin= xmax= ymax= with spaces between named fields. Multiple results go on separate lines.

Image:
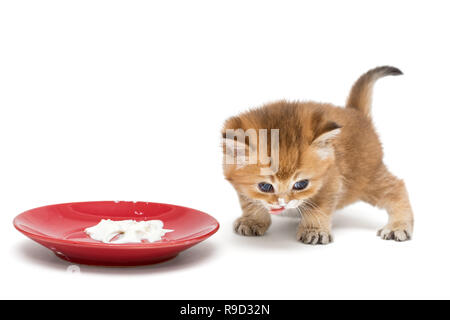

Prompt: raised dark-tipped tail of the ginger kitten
xmin=346 ymin=66 xmax=403 ymax=118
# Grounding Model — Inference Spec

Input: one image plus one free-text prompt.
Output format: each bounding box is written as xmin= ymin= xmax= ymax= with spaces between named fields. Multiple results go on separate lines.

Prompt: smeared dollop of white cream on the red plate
xmin=84 ymin=219 xmax=173 ymax=244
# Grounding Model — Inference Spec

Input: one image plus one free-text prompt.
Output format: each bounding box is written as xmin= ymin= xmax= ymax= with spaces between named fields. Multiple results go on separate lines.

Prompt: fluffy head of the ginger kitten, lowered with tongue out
xmin=224 ymin=102 xmax=341 ymax=213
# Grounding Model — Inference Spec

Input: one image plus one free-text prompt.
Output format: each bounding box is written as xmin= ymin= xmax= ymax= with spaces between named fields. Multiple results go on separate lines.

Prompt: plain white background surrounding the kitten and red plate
xmin=0 ymin=0 xmax=450 ymax=299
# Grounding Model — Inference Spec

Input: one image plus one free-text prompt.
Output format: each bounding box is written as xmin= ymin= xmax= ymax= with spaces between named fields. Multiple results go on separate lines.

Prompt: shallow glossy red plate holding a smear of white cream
xmin=14 ymin=201 xmax=219 ymax=266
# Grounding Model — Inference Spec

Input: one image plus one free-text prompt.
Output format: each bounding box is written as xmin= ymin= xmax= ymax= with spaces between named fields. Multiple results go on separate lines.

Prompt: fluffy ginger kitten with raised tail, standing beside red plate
xmin=222 ymin=66 xmax=413 ymax=245
